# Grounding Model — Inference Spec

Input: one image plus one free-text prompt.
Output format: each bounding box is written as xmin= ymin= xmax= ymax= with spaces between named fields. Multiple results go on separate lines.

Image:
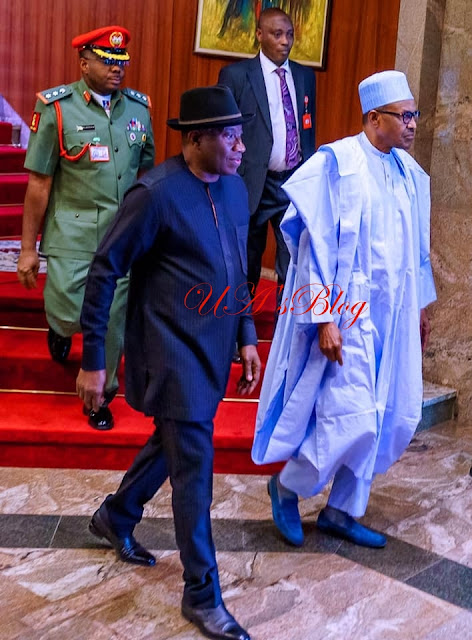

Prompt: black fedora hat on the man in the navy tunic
xmin=167 ymin=84 xmax=254 ymax=131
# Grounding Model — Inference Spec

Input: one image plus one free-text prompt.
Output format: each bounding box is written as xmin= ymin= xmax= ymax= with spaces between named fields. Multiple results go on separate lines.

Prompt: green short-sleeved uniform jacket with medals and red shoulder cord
xmin=25 ymin=79 xmax=154 ymax=260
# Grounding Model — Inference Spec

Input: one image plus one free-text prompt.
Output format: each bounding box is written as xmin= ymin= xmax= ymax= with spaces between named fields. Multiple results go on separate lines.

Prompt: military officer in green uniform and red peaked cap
xmin=18 ymin=26 xmax=154 ymax=430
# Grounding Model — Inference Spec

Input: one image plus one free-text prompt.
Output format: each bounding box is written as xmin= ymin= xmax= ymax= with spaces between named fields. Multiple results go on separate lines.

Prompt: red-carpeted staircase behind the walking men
xmin=0 ymin=123 xmax=455 ymax=474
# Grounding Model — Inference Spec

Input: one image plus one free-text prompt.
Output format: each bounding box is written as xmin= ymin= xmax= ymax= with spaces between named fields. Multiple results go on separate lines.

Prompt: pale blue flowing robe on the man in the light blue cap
xmin=252 ymin=134 xmax=436 ymax=497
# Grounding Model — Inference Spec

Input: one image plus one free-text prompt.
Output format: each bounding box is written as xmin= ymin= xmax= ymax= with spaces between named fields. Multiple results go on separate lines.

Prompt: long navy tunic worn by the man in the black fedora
xmin=81 ymin=156 xmax=257 ymax=421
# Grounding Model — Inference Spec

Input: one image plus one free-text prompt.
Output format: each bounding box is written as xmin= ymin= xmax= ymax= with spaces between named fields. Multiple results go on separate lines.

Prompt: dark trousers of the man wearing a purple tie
xmin=247 ymin=169 xmax=295 ymax=307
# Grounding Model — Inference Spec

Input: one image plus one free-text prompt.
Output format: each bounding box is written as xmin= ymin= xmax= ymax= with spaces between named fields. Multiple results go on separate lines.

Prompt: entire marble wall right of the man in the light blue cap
xmin=397 ymin=0 xmax=472 ymax=420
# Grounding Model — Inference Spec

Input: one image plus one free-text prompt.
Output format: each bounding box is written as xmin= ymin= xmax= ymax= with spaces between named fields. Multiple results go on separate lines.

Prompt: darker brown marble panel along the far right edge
xmin=425 ymin=0 xmax=472 ymax=418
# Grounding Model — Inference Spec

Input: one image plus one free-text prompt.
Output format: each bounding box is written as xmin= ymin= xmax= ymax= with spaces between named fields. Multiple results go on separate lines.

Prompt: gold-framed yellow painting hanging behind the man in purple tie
xmin=194 ymin=0 xmax=332 ymax=70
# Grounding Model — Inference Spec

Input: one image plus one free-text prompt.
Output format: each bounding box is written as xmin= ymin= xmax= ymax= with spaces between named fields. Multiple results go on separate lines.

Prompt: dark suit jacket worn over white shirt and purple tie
xmin=218 ymin=55 xmax=315 ymax=215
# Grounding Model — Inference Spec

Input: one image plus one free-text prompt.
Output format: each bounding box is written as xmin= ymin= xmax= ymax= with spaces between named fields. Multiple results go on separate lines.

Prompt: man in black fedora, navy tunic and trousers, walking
xmin=77 ymin=86 xmax=260 ymax=640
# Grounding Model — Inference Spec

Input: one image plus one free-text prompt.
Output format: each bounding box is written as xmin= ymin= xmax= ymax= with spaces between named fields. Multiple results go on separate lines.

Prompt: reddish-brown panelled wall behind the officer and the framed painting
xmin=0 ymin=0 xmax=400 ymax=267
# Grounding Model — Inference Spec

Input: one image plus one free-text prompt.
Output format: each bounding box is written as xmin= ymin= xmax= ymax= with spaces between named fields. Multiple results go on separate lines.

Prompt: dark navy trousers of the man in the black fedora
xmin=105 ymin=418 xmax=222 ymax=608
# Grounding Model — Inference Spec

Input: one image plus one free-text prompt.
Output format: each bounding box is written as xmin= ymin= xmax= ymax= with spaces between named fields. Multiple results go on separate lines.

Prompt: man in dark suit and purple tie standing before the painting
xmin=218 ymin=8 xmax=315 ymax=312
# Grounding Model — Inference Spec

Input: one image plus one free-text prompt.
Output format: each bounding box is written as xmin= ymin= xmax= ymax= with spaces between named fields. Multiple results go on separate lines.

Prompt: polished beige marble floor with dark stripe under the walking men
xmin=0 ymin=422 xmax=472 ymax=640
